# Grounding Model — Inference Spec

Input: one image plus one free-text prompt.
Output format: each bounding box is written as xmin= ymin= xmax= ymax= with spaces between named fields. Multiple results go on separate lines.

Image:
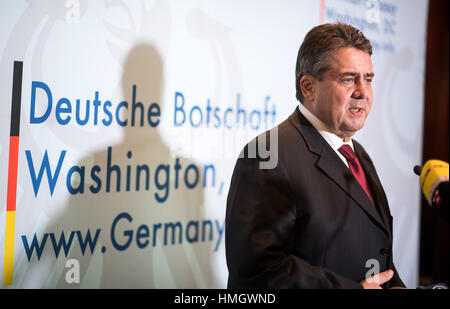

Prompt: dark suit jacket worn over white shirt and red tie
xmin=225 ymin=109 xmax=404 ymax=288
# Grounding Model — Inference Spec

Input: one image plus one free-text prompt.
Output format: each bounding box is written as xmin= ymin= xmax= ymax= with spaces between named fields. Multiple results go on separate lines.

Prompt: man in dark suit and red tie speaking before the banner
xmin=225 ymin=23 xmax=404 ymax=288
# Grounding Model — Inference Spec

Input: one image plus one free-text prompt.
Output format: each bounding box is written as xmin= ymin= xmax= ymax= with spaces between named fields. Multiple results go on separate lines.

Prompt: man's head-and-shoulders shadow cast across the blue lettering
xmin=23 ymin=44 xmax=216 ymax=288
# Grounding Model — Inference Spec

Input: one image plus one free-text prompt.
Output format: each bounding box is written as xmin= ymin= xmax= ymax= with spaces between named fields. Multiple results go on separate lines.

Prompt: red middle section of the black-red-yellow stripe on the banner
xmin=6 ymin=136 xmax=19 ymax=211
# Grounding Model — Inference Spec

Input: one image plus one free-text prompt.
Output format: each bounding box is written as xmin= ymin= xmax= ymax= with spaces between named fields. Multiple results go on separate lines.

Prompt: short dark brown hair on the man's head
xmin=295 ymin=23 xmax=372 ymax=103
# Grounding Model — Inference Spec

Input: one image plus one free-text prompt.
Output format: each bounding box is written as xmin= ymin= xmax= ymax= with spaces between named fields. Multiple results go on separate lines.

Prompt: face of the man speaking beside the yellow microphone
xmin=307 ymin=47 xmax=374 ymax=140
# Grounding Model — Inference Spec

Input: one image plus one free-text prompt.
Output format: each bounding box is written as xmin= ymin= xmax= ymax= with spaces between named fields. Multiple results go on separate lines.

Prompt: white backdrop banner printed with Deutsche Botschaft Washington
xmin=0 ymin=0 xmax=428 ymax=288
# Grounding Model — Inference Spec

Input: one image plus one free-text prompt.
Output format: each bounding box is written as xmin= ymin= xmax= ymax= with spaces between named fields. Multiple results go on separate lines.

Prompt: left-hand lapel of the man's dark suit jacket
xmin=289 ymin=109 xmax=389 ymax=235
